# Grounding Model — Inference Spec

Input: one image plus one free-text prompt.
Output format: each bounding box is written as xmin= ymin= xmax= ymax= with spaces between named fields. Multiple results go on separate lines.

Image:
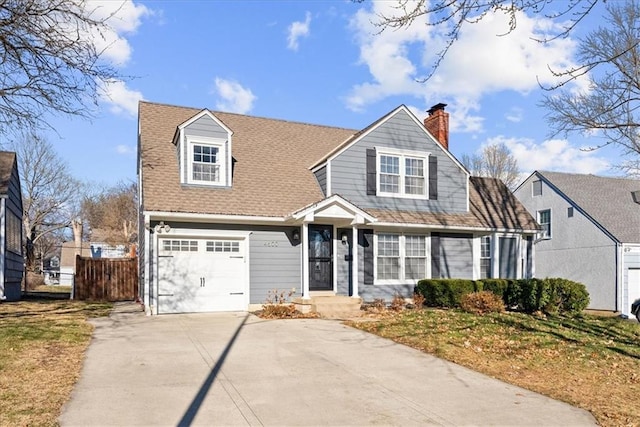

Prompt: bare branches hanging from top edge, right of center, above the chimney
xmin=354 ymin=0 xmax=598 ymax=81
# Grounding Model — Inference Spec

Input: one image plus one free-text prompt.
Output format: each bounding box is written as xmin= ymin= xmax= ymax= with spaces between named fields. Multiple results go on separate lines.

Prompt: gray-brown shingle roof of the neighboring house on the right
xmin=536 ymin=171 xmax=640 ymax=243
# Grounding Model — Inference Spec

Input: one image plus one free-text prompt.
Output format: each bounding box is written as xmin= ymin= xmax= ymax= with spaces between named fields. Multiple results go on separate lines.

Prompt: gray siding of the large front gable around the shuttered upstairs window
xmin=330 ymin=111 xmax=467 ymax=212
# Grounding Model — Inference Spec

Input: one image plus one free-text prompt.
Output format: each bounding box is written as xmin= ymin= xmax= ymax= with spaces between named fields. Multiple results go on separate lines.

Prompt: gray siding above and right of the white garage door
xmin=151 ymin=221 xmax=302 ymax=304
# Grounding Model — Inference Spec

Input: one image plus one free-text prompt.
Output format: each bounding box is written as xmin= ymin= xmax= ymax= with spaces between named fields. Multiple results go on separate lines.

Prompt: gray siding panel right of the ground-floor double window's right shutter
xmin=439 ymin=234 xmax=473 ymax=279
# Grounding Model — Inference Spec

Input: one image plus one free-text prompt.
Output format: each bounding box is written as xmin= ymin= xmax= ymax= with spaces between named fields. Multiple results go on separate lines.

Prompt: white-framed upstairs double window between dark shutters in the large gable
xmin=378 ymin=151 xmax=428 ymax=198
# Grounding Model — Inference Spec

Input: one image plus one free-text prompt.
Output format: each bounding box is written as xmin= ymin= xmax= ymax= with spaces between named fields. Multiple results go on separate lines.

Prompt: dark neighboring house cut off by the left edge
xmin=0 ymin=151 xmax=24 ymax=301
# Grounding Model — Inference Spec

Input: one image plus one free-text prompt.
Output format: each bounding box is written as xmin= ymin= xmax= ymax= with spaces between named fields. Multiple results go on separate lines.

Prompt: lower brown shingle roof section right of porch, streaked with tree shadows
xmin=367 ymin=177 xmax=539 ymax=232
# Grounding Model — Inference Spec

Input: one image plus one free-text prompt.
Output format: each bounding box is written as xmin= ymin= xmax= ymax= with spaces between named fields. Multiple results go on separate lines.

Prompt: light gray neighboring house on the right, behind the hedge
xmin=515 ymin=171 xmax=640 ymax=315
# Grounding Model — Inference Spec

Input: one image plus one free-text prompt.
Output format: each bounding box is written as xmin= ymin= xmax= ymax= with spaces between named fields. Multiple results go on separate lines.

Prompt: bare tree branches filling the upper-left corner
xmin=0 ymin=0 xmax=122 ymax=134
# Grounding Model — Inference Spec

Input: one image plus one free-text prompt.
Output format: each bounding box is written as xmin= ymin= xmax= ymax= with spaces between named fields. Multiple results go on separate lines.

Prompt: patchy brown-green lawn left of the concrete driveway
xmin=0 ymin=301 xmax=112 ymax=426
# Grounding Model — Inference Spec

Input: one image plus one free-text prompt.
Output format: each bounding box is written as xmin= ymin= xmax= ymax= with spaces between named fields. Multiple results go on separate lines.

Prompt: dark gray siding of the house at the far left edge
xmin=3 ymin=160 xmax=24 ymax=301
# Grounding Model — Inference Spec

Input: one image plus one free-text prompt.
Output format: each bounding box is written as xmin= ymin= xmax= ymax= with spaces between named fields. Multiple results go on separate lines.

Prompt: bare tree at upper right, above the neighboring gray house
xmin=542 ymin=0 xmax=640 ymax=173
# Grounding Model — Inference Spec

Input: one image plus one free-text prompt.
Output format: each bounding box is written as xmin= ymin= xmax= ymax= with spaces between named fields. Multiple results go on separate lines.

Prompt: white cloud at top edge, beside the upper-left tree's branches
xmin=85 ymin=0 xmax=152 ymax=66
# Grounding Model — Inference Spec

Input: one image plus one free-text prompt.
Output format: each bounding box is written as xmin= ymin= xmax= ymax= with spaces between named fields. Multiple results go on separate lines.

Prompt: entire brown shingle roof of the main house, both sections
xmin=139 ymin=102 xmax=537 ymax=230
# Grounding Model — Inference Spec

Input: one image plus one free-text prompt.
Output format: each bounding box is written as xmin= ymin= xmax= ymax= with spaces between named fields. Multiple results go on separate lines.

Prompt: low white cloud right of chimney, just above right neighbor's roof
xmin=496 ymin=136 xmax=611 ymax=175
